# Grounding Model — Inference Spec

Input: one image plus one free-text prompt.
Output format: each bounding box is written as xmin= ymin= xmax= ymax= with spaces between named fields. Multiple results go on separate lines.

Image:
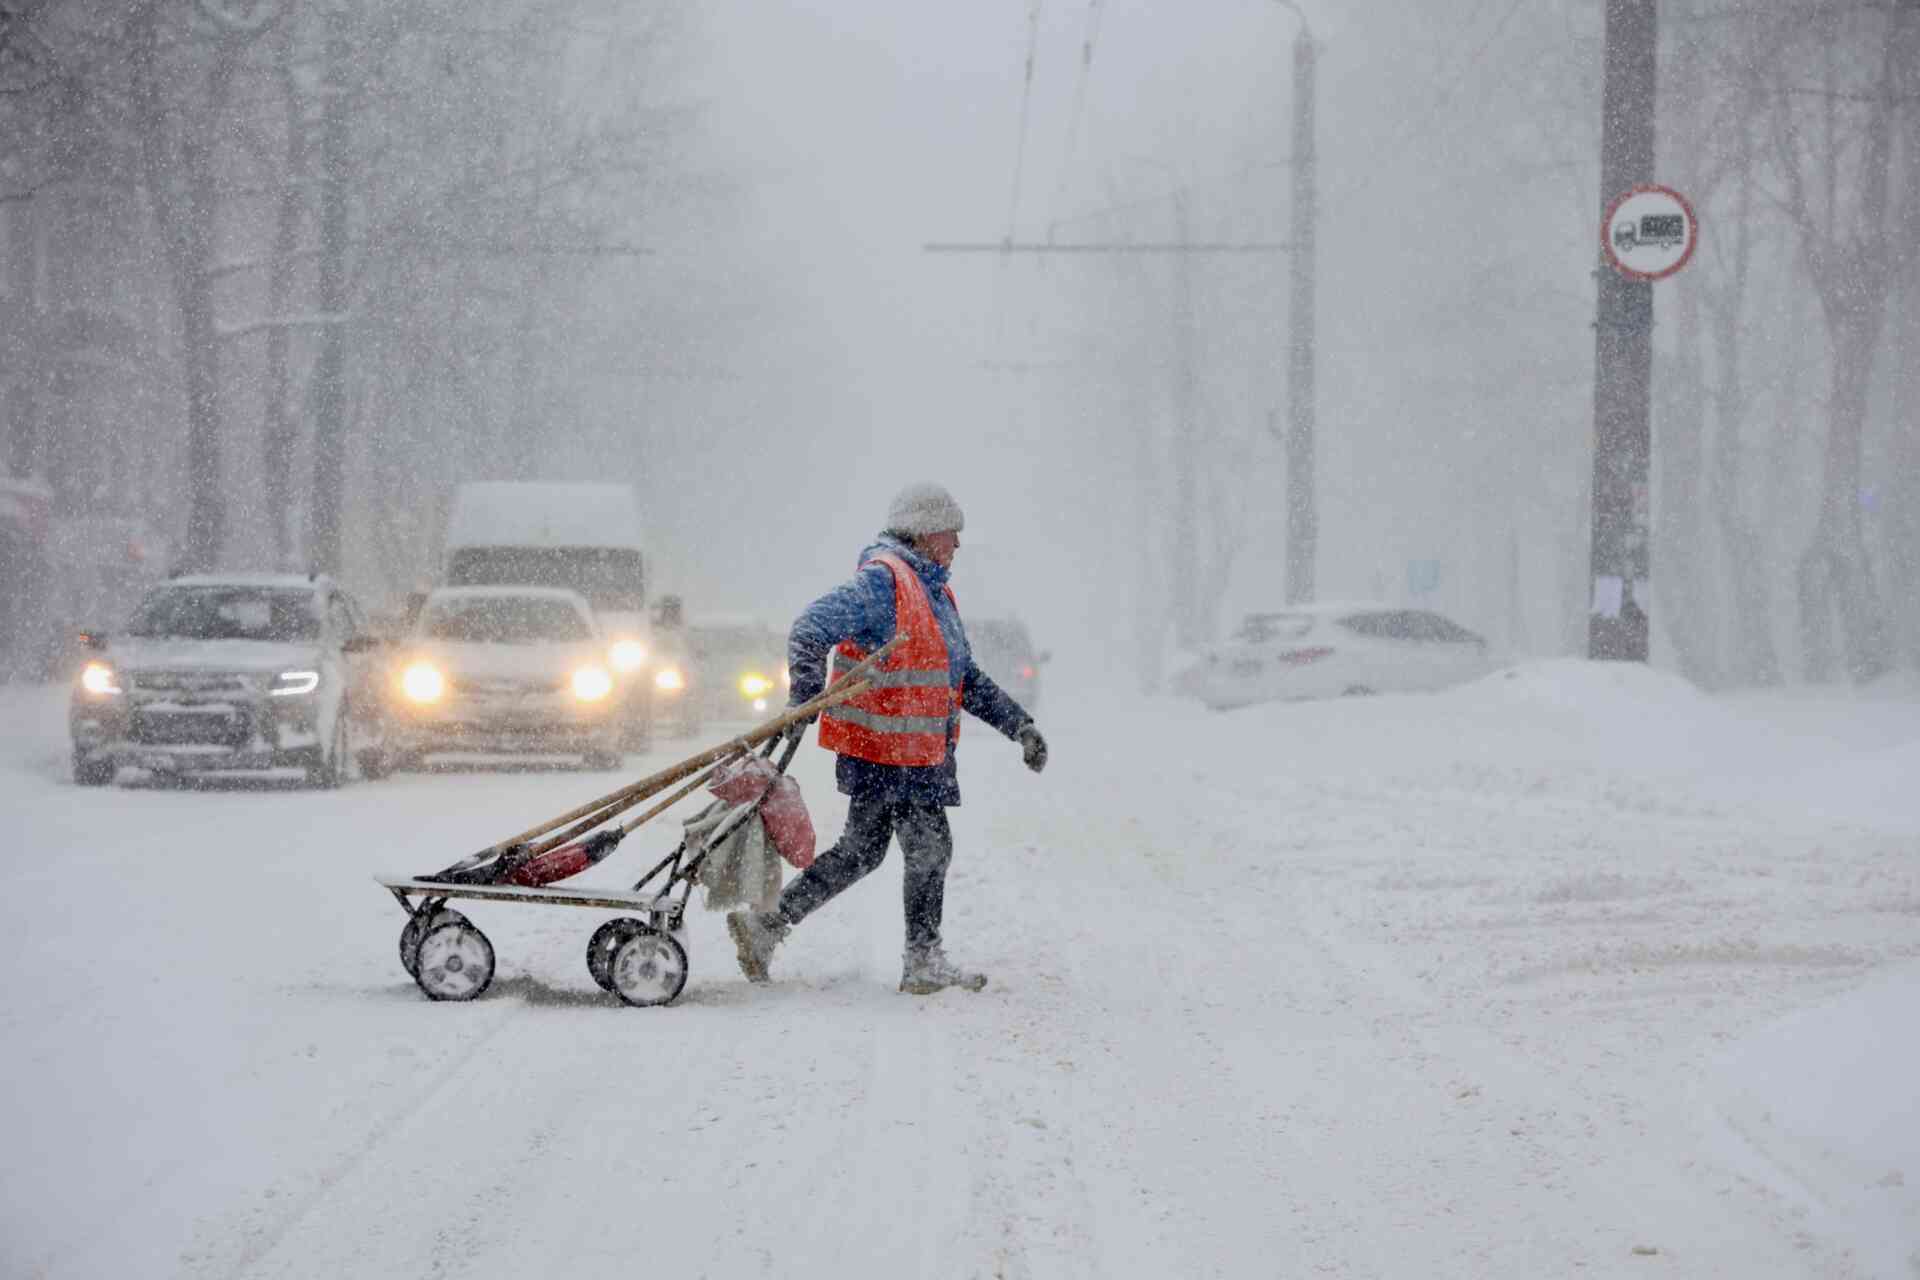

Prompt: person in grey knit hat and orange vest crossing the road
xmin=728 ymin=484 xmax=1046 ymax=996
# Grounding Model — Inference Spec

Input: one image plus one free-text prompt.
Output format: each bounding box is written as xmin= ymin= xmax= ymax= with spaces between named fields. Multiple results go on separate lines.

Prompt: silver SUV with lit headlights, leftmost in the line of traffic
xmin=67 ymin=574 xmax=382 ymax=787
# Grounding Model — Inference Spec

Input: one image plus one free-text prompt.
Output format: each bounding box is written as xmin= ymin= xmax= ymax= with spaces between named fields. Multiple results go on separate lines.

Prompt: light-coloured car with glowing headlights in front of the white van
xmin=386 ymin=587 xmax=622 ymax=770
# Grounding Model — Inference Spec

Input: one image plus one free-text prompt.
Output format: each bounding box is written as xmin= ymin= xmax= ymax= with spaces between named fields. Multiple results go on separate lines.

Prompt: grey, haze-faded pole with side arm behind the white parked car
xmin=1286 ymin=23 xmax=1319 ymax=604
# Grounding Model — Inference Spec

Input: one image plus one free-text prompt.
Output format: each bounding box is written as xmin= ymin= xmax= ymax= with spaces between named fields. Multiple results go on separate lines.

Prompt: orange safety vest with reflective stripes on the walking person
xmin=820 ymin=551 xmax=960 ymax=766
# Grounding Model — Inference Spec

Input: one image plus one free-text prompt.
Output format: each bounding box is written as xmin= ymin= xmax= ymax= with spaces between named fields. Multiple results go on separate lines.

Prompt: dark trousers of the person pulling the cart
xmin=780 ymin=793 xmax=954 ymax=948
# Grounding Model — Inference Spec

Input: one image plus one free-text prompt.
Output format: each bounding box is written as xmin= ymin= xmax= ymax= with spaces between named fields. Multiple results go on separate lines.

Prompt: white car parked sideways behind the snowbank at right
xmin=1175 ymin=604 xmax=1498 ymax=710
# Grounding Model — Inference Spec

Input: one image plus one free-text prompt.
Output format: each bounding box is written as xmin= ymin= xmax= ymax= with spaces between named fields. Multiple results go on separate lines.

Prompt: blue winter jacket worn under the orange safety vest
xmin=787 ymin=533 xmax=1033 ymax=804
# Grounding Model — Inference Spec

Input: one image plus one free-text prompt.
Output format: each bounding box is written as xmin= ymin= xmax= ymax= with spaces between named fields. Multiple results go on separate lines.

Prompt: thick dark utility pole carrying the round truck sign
xmin=1586 ymin=0 xmax=1659 ymax=662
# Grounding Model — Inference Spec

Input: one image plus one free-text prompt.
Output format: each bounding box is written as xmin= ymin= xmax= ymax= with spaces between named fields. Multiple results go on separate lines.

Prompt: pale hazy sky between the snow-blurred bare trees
xmin=602 ymin=0 xmax=1592 ymax=690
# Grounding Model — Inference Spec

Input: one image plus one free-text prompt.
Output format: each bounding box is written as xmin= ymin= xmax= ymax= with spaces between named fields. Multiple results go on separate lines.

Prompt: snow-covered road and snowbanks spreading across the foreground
xmin=0 ymin=662 xmax=1920 ymax=1280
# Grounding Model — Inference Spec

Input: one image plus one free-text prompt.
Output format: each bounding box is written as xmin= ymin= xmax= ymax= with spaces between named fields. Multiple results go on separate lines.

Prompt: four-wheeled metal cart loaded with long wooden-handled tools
xmin=374 ymin=639 xmax=899 ymax=1007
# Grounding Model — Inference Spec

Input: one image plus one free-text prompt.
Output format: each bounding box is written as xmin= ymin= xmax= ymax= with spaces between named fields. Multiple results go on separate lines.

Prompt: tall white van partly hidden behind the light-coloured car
xmin=442 ymin=482 xmax=653 ymax=750
